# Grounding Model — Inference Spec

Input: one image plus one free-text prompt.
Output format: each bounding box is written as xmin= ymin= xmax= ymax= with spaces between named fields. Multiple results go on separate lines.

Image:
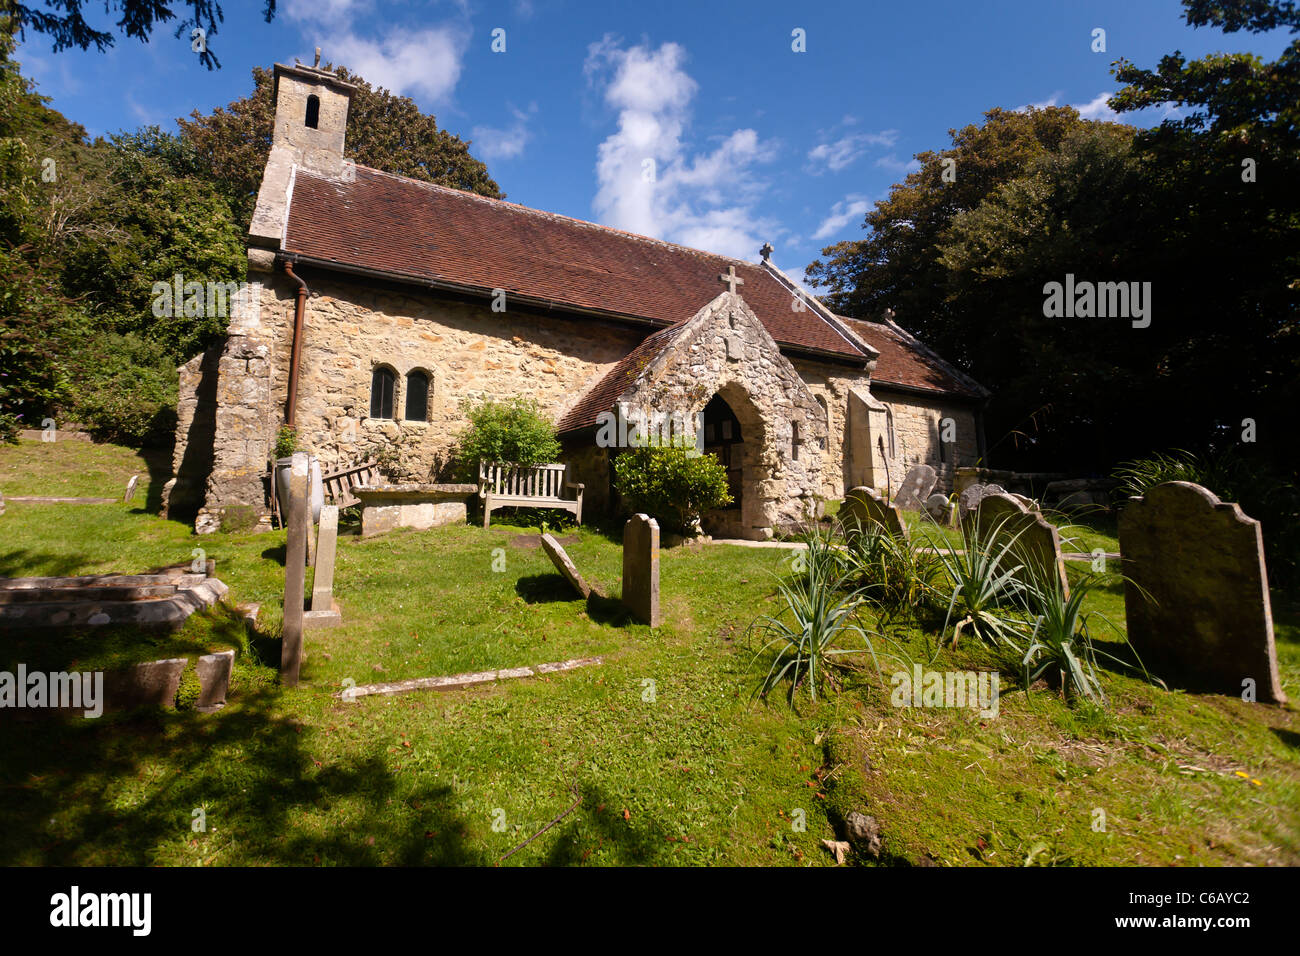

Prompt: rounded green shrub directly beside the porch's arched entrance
xmin=614 ymin=444 xmax=732 ymax=532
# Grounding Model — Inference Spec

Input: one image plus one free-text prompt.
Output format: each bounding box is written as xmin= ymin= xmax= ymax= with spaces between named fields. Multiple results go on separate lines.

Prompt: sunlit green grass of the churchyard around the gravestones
xmin=0 ymin=441 xmax=1300 ymax=866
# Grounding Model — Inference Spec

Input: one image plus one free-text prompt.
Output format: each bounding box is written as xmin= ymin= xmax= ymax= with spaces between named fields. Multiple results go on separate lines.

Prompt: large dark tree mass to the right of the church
xmin=809 ymin=0 xmax=1300 ymax=473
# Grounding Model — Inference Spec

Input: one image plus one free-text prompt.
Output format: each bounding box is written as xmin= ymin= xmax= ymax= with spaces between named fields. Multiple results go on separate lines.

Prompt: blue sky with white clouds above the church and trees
xmin=18 ymin=0 xmax=1287 ymax=282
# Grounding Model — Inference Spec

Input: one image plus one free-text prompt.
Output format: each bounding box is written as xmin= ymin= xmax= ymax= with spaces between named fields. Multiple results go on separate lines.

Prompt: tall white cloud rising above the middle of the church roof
xmin=582 ymin=35 xmax=783 ymax=259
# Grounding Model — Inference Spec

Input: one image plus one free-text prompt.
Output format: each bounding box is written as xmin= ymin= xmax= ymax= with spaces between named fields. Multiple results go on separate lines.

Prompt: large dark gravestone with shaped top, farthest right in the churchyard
xmin=1119 ymin=481 xmax=1287 ymax=704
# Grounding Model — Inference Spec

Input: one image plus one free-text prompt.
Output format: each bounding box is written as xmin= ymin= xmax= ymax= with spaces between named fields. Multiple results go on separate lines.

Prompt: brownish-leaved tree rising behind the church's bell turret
xmin=177 ymin=64 xmax=504 ymax=222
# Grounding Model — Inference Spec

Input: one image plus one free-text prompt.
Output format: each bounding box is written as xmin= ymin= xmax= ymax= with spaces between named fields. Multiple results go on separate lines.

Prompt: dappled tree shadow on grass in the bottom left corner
xmin=0 ymin=688 xmax=491 ymax=866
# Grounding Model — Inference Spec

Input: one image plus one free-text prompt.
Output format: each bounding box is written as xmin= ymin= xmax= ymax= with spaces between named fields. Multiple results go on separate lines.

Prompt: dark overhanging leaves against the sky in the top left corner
xmin=4 ymin=0 xmax=276 ymax=70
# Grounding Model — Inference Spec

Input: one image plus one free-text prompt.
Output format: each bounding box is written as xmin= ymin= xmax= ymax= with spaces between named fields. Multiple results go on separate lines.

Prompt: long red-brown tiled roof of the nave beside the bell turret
xmin=283 ymin=166 xmax=866 ymax=362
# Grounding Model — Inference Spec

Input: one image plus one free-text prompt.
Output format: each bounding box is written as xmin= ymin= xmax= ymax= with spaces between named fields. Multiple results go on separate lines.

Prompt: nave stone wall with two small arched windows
xmin=228 ymin=267 xmax=645 ymax=494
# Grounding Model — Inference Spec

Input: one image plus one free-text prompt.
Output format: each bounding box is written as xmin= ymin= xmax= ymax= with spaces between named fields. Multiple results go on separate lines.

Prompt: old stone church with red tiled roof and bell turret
xmin=165 ymin=64 xmax=988 ymax=538
